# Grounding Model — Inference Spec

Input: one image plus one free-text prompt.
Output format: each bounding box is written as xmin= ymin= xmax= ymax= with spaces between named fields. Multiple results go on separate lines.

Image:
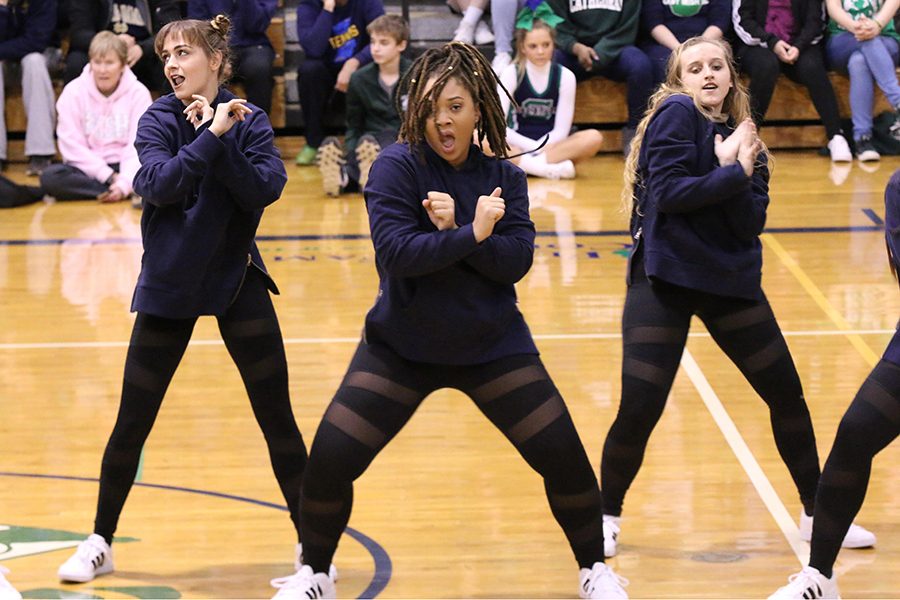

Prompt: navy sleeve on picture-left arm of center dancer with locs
xmin=365 ymin=149 xmax=478 ymax=277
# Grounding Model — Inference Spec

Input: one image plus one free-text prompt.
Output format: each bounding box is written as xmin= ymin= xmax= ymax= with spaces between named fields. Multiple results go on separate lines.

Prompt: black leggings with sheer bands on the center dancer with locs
xmin=300 ymin=342 xmax=603 ymax=573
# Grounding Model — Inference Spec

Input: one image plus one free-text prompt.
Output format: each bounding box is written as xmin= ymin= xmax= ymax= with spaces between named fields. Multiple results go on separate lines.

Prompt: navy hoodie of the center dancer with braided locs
xmin=365 ymin=144 xmax=537 ymax=365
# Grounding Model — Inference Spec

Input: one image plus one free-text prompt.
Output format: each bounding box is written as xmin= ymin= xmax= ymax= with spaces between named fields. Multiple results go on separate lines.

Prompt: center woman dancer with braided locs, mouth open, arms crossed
xmin=273 ymin=42 xmax=627 ymax=600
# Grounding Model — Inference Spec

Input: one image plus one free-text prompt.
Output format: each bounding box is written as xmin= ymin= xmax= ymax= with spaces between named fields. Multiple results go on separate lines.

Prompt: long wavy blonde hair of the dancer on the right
xmin=622 ymin=37 xmax=772 ymax=215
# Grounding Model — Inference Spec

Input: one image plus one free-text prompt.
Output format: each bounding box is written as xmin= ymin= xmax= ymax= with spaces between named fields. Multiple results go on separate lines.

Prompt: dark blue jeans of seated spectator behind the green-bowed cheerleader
xmin=553 ymin=46 xmax=653 ymax=128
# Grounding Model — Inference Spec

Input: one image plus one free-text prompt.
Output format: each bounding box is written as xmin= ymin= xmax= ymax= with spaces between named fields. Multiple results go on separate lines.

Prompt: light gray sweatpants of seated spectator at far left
xmin=0 ymin=52 xmax=56 ymax=160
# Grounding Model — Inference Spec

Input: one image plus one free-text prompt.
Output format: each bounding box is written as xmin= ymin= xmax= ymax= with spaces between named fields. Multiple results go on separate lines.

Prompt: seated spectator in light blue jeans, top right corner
xmin=825 ymin=0 xmax=900 ymax=161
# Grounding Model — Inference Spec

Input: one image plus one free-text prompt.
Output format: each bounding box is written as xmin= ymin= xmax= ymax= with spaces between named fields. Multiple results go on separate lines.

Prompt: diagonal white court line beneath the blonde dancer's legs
xmin=681 ymin=348 xmax=809 ymax=567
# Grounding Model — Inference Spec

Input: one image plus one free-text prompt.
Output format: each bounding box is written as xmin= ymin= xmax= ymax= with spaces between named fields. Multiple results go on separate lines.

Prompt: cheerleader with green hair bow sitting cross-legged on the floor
xmin=498 ymin=0 xmax=603 ymax=179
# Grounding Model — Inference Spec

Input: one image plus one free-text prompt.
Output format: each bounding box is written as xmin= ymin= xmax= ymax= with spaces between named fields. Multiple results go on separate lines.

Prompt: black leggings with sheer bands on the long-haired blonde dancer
xmin=600 ymin=263 xmax=819 ymax=516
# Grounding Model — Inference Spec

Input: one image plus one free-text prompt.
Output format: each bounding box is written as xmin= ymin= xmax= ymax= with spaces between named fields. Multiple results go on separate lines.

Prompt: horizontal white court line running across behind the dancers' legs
xmin=0 ymin=329 xmax=896 ymax=350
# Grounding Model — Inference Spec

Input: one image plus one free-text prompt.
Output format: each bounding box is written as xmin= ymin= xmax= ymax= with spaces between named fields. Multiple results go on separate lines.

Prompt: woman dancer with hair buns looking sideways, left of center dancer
xmin=58 ymin=15 xmax=306 ymax=582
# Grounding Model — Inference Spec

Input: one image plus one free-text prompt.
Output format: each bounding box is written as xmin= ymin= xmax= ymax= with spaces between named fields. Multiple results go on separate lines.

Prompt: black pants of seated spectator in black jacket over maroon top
xmin=736 ymin=44 xmax=841 ymax=140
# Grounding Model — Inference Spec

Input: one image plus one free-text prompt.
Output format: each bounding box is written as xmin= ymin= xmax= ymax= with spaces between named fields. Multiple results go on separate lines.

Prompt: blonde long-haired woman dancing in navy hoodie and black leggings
xmin=600 ymin=37 xmax=875 ymax=557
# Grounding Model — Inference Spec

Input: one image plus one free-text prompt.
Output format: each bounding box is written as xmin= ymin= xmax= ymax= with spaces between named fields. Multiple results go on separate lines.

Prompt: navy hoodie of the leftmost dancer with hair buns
xmin=131 ymin=89 xmax=287 ymax=319
